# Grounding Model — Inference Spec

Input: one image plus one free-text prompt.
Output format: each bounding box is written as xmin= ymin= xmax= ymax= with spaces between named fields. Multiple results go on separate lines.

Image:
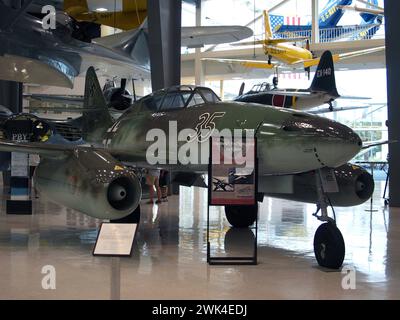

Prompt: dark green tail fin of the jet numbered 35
xmin=82 ymin=67 xmax=113 ymax=142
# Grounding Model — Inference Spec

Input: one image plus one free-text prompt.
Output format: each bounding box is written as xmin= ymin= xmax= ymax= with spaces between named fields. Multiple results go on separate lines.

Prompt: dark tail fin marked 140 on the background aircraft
xmin=309 ymin=51 xmax=339 ymax=97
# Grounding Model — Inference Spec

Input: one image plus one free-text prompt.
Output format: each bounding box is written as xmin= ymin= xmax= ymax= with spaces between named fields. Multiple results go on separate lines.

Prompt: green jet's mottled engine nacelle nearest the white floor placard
xmin=34 ymin=149 xmax=142 ymax=220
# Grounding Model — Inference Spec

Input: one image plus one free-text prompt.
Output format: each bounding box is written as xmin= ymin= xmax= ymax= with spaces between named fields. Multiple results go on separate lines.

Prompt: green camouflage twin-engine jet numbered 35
xmin=0 ymin=67 xmax=373 ymax=268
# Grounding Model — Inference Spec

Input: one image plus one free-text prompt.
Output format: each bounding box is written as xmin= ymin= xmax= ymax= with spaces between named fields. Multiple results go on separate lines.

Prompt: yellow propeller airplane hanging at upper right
xmin=202 ymin=10 xmax=385 ymax=76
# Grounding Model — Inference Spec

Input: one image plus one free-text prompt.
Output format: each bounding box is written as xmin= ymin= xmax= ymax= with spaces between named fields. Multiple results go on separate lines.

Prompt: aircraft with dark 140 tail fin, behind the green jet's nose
xmin=234 ymin=51 xmax=369 ymax=114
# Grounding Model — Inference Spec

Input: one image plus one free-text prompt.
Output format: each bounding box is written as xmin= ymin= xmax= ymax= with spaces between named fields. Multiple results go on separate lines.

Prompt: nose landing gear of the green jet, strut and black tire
xmin=313 ymin=172 xmax=345 ymax=269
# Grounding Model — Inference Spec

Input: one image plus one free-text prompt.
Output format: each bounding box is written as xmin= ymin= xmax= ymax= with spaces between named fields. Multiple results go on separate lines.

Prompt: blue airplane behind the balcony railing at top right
xmin=270 ymin=0 xmax=382 ymax=41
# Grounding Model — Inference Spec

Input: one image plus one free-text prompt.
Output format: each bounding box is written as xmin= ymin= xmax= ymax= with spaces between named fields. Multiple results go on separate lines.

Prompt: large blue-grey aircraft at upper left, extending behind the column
xmin=0 ymin=0 xmax=252 ymax=88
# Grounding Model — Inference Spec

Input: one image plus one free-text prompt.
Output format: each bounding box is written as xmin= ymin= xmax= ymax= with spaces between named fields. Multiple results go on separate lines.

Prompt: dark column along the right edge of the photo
xmin=385 ymin=0 xmax=400 ymax=207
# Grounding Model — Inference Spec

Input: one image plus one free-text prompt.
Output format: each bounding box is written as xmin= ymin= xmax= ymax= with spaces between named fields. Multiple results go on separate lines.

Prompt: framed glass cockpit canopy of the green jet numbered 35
xmin=139 ymin=86 xmax=221 ymax=112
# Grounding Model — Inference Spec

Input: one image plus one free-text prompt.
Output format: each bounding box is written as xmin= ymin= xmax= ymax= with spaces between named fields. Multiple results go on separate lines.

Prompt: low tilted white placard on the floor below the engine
xmin=93 ymin=223 xmax=137 ymax=256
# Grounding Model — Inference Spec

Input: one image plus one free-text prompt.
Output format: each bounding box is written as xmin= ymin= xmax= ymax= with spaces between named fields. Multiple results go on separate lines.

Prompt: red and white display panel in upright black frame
xmin=208 ymin=137 xmax=257 ymax=205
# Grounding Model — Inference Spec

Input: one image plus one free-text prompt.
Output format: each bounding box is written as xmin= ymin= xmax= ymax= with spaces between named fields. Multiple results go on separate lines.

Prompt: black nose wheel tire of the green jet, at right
xmin=314 ymin=222 xmax=346 ymax=269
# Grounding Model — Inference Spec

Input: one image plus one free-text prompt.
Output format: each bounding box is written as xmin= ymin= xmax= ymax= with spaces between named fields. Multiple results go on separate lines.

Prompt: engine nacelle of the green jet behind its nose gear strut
xmin=259 ymin=164 xmax=374 ymax=207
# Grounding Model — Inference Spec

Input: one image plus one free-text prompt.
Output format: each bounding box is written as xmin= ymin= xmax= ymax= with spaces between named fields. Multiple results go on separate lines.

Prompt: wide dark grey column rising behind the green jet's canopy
xmin=148 ymin=0 xmax=182 ymax=91
